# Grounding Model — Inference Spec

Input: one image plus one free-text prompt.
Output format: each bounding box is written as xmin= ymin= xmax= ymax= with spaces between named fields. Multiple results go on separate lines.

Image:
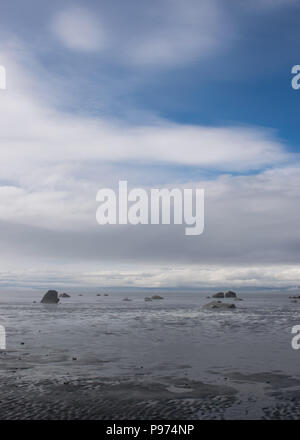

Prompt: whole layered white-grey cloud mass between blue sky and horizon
xmin=0 ymin=46 xmax=300 ymax=287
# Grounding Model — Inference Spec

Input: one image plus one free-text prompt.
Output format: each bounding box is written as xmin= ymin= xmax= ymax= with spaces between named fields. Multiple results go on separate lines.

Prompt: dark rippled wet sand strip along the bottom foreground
xmin=0 ymin=373 xmax=300 ymax=420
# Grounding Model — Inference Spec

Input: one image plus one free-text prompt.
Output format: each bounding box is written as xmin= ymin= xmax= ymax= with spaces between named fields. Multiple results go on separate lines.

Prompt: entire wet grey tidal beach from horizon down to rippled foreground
xmin=0 ymin=292 xmax=300 ymax=420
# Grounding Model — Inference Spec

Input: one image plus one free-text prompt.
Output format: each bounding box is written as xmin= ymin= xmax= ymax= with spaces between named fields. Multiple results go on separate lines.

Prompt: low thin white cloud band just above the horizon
xmin=0 ymin=265 xmax=300 ymax=291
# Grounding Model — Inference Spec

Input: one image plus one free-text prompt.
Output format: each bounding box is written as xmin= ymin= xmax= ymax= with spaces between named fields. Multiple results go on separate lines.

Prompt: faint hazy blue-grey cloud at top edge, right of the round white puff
xmin=122 ymin=0 xmax=231 ymax=67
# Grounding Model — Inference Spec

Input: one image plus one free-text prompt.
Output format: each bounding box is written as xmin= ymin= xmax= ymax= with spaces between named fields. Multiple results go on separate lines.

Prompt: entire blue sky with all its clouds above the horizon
xmin=0 ymin=0 xmax=300 ymax=292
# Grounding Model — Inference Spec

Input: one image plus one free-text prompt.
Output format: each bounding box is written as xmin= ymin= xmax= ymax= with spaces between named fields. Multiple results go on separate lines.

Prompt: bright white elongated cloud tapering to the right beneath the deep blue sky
xmin=0 ymin=51 xmax=291 ymax=181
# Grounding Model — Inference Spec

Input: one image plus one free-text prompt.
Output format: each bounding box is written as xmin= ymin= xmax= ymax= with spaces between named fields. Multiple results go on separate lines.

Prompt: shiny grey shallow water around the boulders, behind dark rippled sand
xmin=0 ymin=292 xmax=300 ymax=418
